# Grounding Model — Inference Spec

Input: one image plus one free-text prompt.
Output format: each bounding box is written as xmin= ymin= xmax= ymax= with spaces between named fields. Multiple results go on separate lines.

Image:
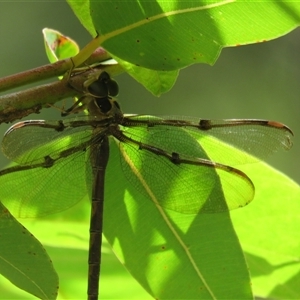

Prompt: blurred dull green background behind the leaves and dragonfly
xmin=0 ymin=0 xmax=300 ymax=298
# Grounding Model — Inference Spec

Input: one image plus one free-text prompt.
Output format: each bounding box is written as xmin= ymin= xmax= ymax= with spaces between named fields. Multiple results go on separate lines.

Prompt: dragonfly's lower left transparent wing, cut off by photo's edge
xmin=0 ymin=151 xmax=87 ymax=218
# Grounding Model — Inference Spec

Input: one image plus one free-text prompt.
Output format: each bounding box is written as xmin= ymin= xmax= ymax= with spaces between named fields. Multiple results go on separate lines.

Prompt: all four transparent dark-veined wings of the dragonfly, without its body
xmin=0 ymin=116 xmax=292 ymax=217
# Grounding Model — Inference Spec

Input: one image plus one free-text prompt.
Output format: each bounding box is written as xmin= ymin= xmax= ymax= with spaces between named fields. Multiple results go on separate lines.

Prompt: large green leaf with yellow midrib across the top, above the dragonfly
xmin=69 ymin=0 xmax=300 ymax=70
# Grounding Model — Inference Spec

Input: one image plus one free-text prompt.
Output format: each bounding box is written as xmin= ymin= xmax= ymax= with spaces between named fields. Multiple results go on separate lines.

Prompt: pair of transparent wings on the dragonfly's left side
xmin=0 ymin=117 xmax=101 ymax=217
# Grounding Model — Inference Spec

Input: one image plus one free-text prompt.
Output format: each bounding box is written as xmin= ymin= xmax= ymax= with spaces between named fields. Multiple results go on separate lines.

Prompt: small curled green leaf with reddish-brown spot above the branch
xmin=43 ymin=28 xmax=79 ymax=63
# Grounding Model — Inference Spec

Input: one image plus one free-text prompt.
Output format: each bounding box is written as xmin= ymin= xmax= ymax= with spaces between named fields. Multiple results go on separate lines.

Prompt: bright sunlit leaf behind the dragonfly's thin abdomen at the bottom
xmin=0 ymin=216 xmax=152 ymax=300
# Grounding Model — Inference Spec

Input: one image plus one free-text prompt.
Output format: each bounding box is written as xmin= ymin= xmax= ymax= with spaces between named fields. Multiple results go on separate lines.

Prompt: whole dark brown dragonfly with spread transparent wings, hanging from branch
xmin=0 ymin=72 xmax=293 ymax=299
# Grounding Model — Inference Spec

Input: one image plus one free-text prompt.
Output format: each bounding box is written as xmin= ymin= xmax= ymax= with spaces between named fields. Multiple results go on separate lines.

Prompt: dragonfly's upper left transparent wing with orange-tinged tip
xmin=2 ymin=117 xmax=92 ymax=165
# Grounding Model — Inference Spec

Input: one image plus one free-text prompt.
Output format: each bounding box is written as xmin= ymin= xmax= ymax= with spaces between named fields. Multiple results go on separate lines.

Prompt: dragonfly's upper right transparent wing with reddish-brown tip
xmin=125 ymin=116 xmax=293 ymax=165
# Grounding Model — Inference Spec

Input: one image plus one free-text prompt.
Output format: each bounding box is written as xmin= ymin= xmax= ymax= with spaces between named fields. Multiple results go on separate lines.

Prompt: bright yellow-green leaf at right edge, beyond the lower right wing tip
xmin=231 ymin=163 xmax=300 ymax=299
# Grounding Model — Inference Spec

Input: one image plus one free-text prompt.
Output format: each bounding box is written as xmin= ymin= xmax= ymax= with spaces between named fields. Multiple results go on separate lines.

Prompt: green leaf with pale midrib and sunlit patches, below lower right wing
xmin=104 ymin=139 xmax=252 ymax=299
